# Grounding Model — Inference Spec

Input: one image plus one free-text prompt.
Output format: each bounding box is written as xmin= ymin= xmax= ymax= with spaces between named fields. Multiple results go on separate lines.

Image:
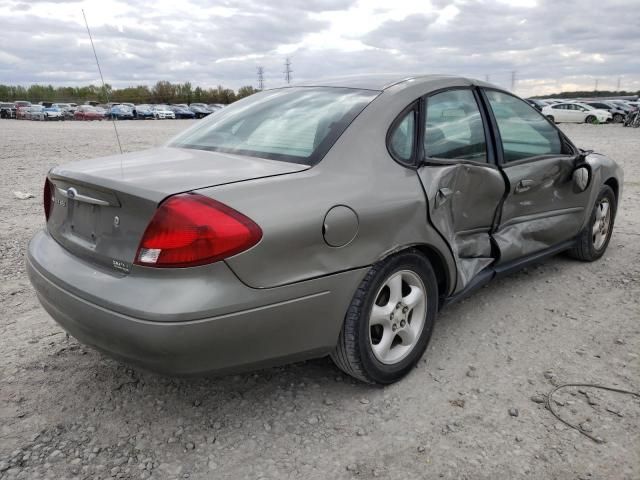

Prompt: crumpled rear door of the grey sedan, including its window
xmin=418 ymin=88 xmax=506 ymax=292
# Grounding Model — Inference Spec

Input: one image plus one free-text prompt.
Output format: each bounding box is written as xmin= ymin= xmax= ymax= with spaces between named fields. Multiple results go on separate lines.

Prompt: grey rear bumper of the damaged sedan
xmin=27 ymin=232 xmax=365 ymax=375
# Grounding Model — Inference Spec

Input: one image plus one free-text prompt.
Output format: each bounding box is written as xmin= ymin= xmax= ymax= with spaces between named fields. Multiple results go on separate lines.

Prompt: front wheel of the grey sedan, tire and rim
xmin=569 ymin=185 xmax=617 ymax=262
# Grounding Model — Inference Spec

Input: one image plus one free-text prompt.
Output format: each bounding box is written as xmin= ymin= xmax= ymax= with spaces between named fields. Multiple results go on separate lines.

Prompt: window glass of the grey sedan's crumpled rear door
xmin=424 ymin=89 xmax=487 ymax=162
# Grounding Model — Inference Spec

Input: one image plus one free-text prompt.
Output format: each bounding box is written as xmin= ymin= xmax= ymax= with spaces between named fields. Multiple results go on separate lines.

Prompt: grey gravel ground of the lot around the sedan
xmin=0 ymin=120 xmax=640 ymax=480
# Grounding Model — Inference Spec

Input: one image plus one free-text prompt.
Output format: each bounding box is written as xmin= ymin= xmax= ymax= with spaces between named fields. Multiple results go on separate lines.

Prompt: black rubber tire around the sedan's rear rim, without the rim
xmin=331 ymin=249 xmax=438 ymax=385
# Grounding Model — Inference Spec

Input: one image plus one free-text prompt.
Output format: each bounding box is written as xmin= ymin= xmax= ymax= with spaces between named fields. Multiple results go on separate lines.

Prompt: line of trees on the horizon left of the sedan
xmin=0 ymin=80 xmax=258 ymax=104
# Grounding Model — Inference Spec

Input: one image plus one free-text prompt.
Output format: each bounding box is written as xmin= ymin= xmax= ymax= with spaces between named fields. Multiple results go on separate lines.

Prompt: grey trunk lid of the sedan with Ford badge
xmin=47 ymin=147 xmax=309 ymax=273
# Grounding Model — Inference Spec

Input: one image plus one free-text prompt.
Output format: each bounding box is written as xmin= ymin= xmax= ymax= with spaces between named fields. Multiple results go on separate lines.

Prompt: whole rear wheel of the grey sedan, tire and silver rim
xmin=331 ymin=250 xmax=438 ymax=384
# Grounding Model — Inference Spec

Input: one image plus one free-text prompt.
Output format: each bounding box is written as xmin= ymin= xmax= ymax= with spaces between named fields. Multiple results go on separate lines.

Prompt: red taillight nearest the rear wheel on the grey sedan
xmin=135 ymin=193 xmax=262 ymax=267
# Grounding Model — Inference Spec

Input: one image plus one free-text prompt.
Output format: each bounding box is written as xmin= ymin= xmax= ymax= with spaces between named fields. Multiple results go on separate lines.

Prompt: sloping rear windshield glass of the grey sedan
xmin=169 ymin=87 xmax=379 ymax=165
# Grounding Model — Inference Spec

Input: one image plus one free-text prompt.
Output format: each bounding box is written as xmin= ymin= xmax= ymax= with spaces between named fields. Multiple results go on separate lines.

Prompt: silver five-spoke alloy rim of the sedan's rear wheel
xmin=369 ymin=270 xmax=427 ymax=365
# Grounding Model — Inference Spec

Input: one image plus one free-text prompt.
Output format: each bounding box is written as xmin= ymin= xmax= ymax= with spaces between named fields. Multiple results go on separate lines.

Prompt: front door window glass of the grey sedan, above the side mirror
xmin=485 ymin=90 xmax=564 ymax=162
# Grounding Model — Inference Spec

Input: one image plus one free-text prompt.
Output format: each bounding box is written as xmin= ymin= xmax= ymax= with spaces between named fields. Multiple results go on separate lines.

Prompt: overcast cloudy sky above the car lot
xmin=0 ymin=0 xmax=640 ymax=96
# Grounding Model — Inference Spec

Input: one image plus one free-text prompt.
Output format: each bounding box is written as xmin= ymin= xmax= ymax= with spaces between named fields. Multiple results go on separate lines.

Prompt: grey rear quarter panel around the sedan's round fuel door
xmin=199 ymin=81 xmax=456 ymax=294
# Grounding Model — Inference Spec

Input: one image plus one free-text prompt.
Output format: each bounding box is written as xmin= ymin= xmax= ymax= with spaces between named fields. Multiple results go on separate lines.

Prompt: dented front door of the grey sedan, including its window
xmin=483 ymin=89 xmax=590 ymax=265
